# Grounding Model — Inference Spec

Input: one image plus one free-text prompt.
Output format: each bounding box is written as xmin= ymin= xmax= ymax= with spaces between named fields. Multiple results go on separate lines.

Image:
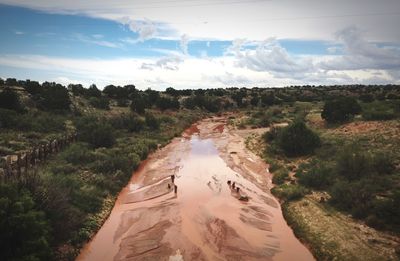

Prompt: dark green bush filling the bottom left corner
xmin=0 ymin=184 xmax=51 ymax=260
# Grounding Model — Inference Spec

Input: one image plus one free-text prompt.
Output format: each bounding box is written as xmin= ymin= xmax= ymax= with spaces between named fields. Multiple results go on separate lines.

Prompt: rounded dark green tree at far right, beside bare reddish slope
xmin=321 ymin=97 xmax=361 ymax=123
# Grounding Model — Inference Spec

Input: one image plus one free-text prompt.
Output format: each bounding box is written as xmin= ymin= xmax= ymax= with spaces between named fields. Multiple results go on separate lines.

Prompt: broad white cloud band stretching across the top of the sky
xmin=0 ymin=0 xmax=400 ymax=42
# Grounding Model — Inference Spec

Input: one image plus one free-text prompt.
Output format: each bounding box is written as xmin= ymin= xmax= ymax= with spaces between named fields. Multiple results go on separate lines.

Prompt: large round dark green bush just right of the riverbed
xmin=278 ymin=121 xmax=321 ymax=156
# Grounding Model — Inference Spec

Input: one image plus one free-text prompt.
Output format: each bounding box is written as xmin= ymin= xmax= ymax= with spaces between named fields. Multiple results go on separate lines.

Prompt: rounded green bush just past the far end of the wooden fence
xmin=76 ymin=117 xmax=115 ymax=148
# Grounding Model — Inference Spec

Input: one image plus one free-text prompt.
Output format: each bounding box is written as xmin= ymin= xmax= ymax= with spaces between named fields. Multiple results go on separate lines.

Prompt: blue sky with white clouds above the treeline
xmin=0 ymin=0 xmax=400 ymax=90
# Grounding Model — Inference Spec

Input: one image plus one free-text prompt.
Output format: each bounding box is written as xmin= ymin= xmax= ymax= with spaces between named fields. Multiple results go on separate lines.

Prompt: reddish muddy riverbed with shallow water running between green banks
xmin=78 ymin=118 xmax=313 ymax=260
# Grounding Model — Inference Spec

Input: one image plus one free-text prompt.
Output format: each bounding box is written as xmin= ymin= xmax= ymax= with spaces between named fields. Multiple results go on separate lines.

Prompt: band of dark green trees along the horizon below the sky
xmin=0 ymin=78 xmax=400 ymax=114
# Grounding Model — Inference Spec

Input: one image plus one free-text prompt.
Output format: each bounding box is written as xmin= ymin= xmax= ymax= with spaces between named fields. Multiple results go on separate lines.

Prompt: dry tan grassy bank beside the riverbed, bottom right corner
xmin=282 ymin=195 xmax=397 ymax=261
